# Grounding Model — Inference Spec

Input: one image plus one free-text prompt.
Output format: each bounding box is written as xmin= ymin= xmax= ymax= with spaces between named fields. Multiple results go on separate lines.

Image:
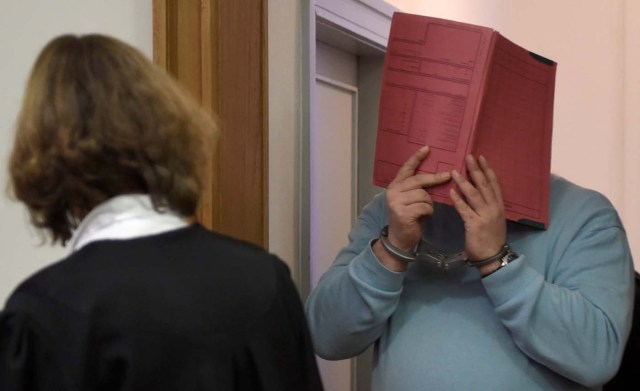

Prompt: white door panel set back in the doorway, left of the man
xmin=310 ymin=42 xmax=358 ymax=391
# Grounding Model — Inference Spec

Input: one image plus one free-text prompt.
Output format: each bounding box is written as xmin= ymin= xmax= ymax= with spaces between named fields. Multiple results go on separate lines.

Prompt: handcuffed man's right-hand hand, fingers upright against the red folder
xmin=450 ymin=155 xmax=507 ymax=266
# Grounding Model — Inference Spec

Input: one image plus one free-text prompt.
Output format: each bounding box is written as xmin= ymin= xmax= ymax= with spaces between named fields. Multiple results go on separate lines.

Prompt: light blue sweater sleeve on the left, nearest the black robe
xmin=305 ymin=193 xmax=405 ymax=360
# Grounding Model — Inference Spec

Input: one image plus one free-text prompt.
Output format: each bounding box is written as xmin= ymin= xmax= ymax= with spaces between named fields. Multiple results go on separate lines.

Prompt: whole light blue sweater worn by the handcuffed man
xmin=306 ymin=176 xmax=633 ymax=391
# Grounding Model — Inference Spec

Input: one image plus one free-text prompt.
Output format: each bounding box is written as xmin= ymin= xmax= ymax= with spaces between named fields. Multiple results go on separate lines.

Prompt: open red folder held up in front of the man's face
xmin=373 ymin=12 xmax=557 ymax=228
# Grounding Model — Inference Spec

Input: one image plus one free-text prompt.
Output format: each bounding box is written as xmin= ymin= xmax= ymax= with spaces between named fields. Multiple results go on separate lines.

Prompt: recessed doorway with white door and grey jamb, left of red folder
xmin=303 ymin=2 xmax=390 ymax=391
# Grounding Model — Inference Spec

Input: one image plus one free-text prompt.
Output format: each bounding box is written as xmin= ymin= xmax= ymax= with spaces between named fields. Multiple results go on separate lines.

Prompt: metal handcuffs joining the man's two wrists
xmin=379 ymin=225 xmax=518 ymax=270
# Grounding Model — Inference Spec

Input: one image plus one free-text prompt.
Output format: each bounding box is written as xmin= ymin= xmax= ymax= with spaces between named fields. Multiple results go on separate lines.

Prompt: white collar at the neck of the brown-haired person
xmin=67 ymin=194 xmax=189 ymax=253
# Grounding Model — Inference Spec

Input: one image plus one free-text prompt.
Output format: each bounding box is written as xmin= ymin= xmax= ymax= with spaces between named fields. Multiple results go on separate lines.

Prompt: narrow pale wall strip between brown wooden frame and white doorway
xmin=268 ymin=0 xmax=302 ymax=276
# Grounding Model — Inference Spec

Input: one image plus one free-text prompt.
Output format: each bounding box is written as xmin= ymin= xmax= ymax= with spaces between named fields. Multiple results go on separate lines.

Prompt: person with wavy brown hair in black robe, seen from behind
xmin=0 ymin=34 xmax=322 ymax=391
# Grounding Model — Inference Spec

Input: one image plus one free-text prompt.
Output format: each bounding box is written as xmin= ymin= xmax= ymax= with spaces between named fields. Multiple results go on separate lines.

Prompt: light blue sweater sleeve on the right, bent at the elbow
xmin=483 ymin=191 xmax=634 ymax=387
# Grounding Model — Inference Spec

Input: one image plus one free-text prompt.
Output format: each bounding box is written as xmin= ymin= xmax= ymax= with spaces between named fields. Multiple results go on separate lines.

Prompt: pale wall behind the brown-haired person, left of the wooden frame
xmin=0 ymin=0 xmax=152 ymax=307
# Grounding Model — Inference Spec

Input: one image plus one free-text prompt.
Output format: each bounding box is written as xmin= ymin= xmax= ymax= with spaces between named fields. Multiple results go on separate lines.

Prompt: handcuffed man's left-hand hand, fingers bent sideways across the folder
xmin=374 ymin=146 xmax=451 ymax=270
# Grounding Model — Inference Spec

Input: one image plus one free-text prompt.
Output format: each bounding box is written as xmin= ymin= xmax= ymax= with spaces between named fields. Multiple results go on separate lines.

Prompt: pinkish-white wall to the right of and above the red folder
xmin=387 ymin=0 xmax=640 ymax=270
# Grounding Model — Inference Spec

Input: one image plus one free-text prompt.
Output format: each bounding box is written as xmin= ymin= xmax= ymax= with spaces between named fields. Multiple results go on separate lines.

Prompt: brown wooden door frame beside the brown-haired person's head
xmin=153 ymin=0 xmax=268 ymax=248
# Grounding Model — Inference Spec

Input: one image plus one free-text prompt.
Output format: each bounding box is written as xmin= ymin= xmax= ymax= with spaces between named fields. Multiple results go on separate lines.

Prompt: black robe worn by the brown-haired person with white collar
xmin=0 ymin=225 xmax=322 ymax=391
